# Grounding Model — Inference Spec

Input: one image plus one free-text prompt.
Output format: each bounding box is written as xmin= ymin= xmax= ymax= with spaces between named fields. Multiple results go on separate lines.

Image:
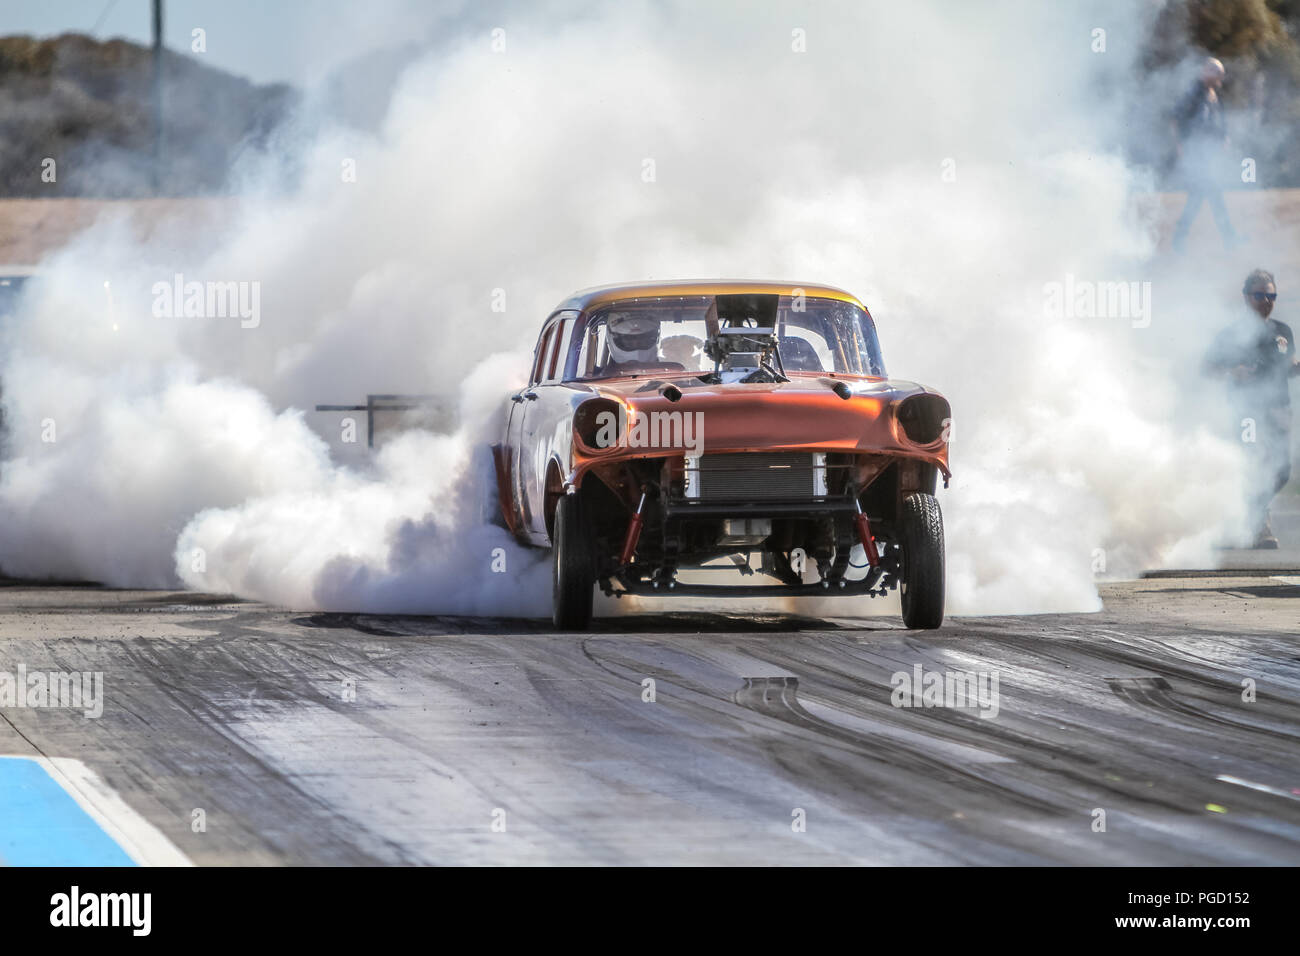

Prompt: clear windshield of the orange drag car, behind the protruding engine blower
xmin=566 ymin=295 xmax=885 ymax=380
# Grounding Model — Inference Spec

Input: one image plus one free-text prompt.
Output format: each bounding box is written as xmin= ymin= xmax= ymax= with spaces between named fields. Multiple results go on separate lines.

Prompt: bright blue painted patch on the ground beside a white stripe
xmin=0 ymin=757 xmax=135 ymax=866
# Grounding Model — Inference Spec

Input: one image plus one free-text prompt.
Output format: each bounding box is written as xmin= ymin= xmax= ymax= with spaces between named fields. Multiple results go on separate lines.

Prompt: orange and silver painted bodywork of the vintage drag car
xmin=495 ymin=281 xmax=949 ymax=546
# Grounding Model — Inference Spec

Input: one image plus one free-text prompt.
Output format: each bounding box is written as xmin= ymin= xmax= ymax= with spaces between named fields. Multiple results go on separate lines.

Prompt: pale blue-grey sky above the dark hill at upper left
xmin=0 ymin=0 xmax=463 ymax=87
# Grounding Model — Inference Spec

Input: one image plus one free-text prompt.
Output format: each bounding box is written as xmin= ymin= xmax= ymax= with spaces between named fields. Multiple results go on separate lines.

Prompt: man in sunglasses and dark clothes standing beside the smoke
xmin=1209 ymin=269 xmax=1300 ymax=548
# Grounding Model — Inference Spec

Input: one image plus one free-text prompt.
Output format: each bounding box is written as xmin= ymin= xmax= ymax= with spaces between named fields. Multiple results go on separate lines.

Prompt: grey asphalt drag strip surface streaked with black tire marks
xmin=0 ymin=575 xmax=1300 ymax=865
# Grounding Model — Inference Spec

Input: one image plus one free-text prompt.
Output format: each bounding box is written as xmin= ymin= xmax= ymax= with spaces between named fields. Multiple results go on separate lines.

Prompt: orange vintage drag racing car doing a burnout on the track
xmin=493 ymin=282 xmax=950 ymax=630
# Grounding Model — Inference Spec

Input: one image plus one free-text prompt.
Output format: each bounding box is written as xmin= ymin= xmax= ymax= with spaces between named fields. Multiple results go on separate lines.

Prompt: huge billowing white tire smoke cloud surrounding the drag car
xmin=0 ymin=3 xmax=1263 ymax=614
